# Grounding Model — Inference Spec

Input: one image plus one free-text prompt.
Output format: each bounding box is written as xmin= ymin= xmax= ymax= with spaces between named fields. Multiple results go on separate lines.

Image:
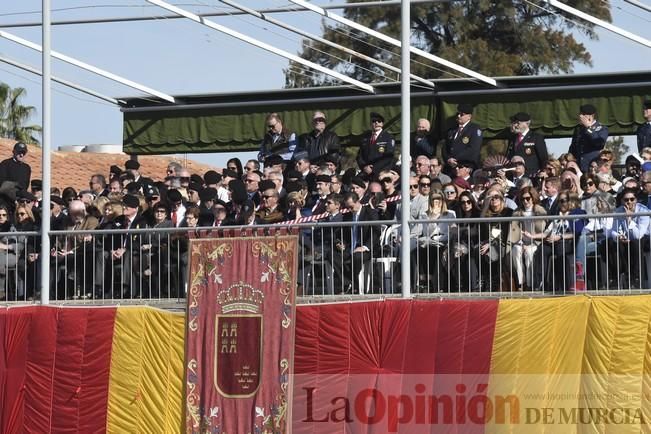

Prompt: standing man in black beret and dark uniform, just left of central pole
xmin=357 ymin=112 xmax=396 ymax=175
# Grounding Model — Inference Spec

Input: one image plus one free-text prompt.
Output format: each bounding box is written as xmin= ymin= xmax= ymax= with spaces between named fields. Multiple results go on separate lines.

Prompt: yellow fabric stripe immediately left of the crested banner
xmin=107 ymin=307 xmax=185 ymax=434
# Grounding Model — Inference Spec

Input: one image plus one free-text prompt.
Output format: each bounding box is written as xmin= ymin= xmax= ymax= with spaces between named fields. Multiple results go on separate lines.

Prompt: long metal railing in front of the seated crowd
xmin=0 ymin=214 xmax=651 ymax=304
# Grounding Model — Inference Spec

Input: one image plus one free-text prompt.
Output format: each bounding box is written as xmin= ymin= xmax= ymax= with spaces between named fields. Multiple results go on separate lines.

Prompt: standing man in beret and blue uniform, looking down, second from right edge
xmin=567 ymin=104 xmax=608 ymax=172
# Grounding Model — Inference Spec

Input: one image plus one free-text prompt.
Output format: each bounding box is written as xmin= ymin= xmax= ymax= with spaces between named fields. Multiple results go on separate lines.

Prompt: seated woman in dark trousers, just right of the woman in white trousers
xmin=530 ymin=190 xmax=586 ymax=293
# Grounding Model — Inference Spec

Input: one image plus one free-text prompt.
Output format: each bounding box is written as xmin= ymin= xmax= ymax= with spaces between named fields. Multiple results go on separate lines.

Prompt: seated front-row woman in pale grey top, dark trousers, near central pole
xmin=414 ymin=191 xmax=455 ymax=292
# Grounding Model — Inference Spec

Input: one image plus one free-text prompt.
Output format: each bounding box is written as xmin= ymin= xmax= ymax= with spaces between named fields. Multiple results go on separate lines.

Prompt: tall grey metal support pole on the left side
xmin=39 ymin=0 xmax=52 ymax=304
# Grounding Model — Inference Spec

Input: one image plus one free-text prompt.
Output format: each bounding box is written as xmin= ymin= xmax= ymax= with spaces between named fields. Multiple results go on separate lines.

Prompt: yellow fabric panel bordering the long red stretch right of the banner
xmin=486 ymin=297 xmax=590 ymax=434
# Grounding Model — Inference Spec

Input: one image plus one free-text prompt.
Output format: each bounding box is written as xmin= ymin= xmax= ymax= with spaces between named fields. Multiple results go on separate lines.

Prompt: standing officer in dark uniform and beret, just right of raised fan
xmin=506 ymin=112 xmax=549 ymax=177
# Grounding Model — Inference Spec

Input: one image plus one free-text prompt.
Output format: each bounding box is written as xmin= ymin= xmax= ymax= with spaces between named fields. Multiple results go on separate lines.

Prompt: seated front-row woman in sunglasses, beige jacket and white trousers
xmin=510 ymin=186 xmax=547 ymax=291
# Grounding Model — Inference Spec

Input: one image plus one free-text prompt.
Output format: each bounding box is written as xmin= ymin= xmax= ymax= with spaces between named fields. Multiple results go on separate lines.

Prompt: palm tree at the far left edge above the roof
xmin=0 ymin=83 xmax=42 ymax=145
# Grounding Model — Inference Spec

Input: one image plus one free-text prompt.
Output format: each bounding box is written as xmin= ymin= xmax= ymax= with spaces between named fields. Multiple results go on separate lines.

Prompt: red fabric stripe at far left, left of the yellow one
xmin=0 ymin=307 xmax=115 ymax=434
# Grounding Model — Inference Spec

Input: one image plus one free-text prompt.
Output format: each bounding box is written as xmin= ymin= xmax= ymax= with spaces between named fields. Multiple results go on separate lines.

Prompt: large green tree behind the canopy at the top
xmin=285 ymin=0 xmax=611 ymax=87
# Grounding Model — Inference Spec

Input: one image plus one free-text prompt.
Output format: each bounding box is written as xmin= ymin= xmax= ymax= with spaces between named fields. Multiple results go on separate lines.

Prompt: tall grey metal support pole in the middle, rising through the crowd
xmin=400 ymin=0 xmax=411 ymax=298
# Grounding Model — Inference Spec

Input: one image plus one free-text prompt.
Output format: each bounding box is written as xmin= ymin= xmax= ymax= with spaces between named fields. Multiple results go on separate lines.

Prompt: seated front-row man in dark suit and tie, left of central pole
xmin=341 ymin=192 xmax=380 ymax=292
